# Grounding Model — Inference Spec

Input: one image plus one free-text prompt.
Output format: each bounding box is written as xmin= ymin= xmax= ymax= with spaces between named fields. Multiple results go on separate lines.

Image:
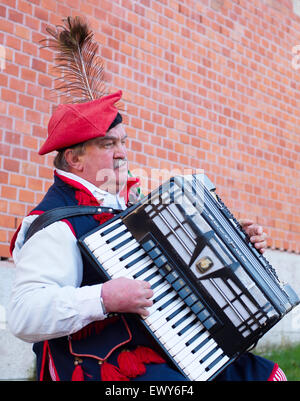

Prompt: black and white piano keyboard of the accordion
xmin=85 ymin=219 xmax=229 ymax=381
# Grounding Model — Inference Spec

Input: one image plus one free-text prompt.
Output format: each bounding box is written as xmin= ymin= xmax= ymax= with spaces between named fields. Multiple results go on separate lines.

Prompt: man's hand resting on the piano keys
xmin=101 ymin=277 xmax=153 ymax=316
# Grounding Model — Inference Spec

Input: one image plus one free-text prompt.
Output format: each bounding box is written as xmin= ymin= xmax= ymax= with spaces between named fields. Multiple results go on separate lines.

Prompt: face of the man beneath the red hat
xmin=80 ymin=124 xmax=128 ymax=194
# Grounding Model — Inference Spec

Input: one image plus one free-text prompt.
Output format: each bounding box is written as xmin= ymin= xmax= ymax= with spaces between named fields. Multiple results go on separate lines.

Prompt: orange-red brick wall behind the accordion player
xmin=0 ymin=0 xmax=300 ymax=257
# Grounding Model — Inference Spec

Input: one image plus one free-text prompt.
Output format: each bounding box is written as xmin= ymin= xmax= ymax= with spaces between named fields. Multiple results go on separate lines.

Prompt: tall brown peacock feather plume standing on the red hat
xmin=43 ymin=17 xmax=107 ymax=103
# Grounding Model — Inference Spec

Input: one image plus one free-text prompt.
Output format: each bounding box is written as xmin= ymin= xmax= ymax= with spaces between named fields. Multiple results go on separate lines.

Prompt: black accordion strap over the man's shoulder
xmin=24 ymin=206 xmax=122 ymax=243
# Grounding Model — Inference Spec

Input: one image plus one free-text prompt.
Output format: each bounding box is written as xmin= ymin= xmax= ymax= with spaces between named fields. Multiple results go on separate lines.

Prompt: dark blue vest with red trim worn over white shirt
xmin=32 ymin=176 xmax=274 ymax=381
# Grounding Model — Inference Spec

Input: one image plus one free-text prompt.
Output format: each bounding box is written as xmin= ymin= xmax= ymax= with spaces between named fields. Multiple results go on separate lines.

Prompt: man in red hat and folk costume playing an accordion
xmin=8 ymin=91 xmax=284 ymax=380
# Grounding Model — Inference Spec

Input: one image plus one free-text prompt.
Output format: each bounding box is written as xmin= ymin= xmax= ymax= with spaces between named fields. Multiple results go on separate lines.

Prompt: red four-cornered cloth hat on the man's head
xmin=39 ymin=91 xmax=122 ymax=155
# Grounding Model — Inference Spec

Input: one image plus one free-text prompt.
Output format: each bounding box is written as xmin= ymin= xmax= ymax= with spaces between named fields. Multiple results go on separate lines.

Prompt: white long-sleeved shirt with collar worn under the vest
xmin=8 ymin=170 xmax=126 ymax=342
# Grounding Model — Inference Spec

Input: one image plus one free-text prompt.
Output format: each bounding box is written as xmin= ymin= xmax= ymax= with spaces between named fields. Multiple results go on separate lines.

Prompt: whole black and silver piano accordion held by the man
xmin=79 ymin=174 xmax=299 ymax=381
